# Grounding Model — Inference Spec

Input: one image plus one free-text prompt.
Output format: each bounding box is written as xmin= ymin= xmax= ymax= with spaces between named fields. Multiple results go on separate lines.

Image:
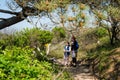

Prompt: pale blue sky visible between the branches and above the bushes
xmin=0 ymin=0 xmax=95 ymax=33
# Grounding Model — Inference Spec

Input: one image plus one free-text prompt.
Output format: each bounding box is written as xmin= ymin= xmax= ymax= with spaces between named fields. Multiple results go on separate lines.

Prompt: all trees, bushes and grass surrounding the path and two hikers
xmin=0 ymin=0 xmax=120 ymax=80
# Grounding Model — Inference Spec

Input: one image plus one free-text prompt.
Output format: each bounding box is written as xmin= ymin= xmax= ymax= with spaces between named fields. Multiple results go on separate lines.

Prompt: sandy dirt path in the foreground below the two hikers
xmin=57 ymin=59 xmax=98 ymax=80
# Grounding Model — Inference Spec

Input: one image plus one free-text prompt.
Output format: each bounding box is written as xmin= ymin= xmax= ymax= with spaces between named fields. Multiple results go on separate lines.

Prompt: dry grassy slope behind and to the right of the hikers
xmin=49 ymin=29 xmax=120 ymax=80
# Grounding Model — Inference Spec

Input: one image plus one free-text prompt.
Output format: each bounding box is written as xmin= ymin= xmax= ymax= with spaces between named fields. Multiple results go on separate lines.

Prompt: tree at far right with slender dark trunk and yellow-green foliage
xmin=73 ymin=0 xmax=120 ymax=45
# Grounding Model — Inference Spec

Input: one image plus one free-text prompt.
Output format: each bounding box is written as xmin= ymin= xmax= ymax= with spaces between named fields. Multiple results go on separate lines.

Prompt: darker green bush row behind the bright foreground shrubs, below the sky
xmin=1 ymin=28 xmax=53 ymax=48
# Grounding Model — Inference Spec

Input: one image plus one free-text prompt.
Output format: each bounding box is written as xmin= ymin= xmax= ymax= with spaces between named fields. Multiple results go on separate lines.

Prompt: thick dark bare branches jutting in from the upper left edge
xmin=0 ymin=7 xmax=36 ymax=29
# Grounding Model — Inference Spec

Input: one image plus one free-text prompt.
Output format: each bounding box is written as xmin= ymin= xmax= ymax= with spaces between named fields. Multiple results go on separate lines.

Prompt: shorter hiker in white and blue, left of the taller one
xmin=64 ymin=42 xmax=71 ymax=66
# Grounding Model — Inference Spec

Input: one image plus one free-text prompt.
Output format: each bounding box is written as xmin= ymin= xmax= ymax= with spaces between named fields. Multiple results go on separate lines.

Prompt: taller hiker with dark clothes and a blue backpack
xmin=71 ymin=36 xmax=79 ymax=66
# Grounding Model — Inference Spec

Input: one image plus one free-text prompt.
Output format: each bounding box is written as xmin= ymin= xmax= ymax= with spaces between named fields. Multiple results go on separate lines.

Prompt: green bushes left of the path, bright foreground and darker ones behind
xmin=0 ymin=28 xmax=70 ymax=80
